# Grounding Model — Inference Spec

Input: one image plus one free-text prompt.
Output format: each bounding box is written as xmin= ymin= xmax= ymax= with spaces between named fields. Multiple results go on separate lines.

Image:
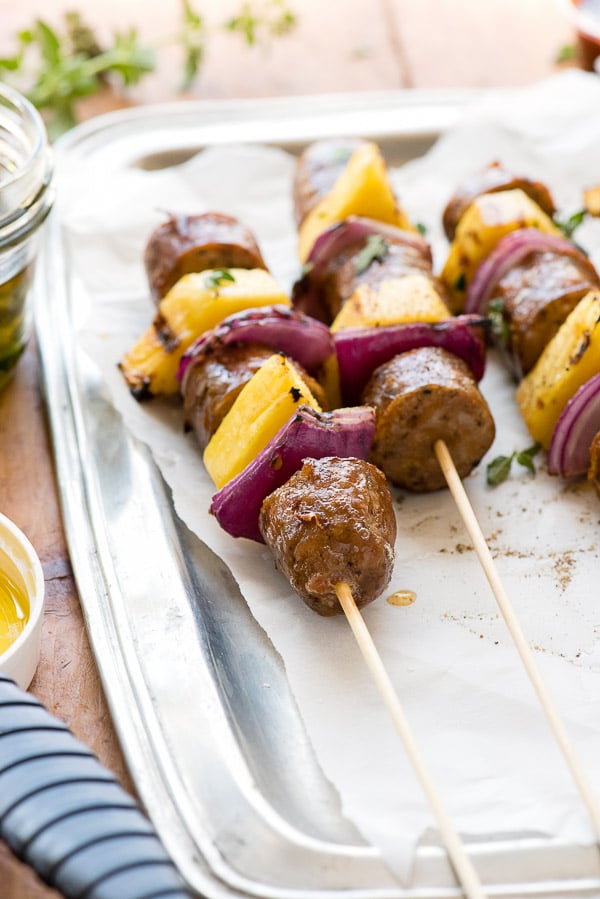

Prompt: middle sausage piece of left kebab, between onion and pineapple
xmin=182 ymin=343 xmax=328 ymax=450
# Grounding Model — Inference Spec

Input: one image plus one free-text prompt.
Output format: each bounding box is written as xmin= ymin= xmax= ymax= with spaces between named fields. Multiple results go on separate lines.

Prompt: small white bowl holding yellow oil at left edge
xmin=0 ymin=513 xmax=44 ymax=690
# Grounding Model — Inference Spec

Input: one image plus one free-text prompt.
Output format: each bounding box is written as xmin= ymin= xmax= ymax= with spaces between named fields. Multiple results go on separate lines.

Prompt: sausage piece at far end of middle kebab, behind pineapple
xmin=293 ymin=138 xmax=367 ymax=225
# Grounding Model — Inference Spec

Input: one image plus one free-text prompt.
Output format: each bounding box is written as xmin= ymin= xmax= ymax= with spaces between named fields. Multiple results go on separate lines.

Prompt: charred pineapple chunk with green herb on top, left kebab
xmin=119 ymin=268 xmax=290 ymax=399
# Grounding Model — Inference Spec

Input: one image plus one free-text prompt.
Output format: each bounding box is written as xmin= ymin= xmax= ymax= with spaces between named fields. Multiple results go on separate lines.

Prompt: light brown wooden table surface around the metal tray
xmin=0 ymin=0 xmax=574 ymax=899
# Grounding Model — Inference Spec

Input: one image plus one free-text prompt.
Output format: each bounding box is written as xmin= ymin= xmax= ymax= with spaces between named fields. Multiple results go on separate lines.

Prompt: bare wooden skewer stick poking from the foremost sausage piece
xmin=335 ymin=582 xmax=486 ymax=899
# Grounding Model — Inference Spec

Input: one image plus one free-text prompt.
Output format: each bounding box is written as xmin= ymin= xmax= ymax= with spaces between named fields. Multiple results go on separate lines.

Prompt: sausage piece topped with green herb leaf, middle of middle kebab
xmin=292 ymin=235 xmax=446 ymax=325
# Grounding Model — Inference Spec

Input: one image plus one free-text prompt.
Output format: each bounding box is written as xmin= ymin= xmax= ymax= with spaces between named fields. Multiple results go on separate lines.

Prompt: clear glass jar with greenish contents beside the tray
xmin=0 ymin=83 xmax=52 ymax=390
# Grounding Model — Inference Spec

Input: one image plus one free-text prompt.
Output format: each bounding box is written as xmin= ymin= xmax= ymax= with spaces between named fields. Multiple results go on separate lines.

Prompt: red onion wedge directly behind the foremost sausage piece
xmin=210 ymin=406 xmax=375 ymax=543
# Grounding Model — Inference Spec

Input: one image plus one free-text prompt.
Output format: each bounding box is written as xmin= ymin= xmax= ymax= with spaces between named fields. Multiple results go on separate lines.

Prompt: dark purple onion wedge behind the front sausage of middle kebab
xmin=334 ymin=315 xmax=485 ymax=403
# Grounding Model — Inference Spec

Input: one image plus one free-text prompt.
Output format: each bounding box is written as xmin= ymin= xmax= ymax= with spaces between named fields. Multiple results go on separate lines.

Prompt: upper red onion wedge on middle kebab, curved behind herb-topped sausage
xmin=292 ymin=215 xmax=432 ymax=321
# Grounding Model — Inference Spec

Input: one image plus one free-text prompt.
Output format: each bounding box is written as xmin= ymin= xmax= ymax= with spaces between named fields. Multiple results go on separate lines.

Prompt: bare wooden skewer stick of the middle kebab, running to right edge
xmin=434 ymin=440 xmax=600 ymax=840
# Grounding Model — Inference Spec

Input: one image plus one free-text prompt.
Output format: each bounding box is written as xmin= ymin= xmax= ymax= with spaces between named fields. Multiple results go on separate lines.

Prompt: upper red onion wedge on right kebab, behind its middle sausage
xmin=465 ymin=228 xmax=589 ymax=315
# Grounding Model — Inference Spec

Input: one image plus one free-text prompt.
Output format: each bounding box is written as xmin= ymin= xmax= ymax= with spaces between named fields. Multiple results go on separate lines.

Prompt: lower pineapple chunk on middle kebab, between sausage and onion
xmin=331 ymin=275 xmax=450 ymax=331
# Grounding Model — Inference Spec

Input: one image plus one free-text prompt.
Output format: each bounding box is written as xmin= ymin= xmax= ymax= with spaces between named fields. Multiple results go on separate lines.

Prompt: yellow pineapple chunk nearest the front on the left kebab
xmin=203 ymin=353 xmax=321 ymax=490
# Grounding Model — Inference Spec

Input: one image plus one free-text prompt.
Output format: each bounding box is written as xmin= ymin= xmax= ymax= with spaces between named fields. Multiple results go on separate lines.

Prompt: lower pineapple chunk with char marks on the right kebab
xmin=517 ymin=290 xmax=600 ymax=449
